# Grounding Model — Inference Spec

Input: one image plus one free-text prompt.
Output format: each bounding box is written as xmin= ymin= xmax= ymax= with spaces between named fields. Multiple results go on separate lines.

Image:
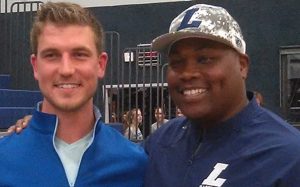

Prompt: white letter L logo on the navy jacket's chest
xmin=199 ymin=163 xmax=228 ymax=187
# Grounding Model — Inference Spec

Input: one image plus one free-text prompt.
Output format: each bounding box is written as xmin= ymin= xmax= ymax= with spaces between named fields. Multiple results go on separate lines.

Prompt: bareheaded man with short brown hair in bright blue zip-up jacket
xmin=0 ymin=2 xmax=147 ymax=187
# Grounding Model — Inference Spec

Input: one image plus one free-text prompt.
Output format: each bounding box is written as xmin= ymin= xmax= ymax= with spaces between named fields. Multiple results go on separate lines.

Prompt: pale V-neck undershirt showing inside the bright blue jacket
xmin=54 ymin=131 xmax=93 ymax=187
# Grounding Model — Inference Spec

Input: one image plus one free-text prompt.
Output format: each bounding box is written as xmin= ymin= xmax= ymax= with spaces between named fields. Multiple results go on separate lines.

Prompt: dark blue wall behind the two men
xmin=0 ymin=0 xmax=300 ymax=113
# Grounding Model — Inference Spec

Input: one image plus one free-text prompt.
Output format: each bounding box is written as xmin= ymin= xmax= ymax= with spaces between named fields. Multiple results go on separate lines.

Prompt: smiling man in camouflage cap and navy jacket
xmin=145 ymin=4 xmax=300 ymax=187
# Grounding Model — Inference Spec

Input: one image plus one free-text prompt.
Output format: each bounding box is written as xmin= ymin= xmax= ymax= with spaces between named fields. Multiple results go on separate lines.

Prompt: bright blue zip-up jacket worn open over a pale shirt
xmin=0 ymin=106 xmax=147 ymax=187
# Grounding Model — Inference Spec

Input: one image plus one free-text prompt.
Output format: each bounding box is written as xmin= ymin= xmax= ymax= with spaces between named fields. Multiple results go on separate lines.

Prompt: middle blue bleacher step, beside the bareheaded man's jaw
xmin=0 ymin=89 xmax=43 ymax=107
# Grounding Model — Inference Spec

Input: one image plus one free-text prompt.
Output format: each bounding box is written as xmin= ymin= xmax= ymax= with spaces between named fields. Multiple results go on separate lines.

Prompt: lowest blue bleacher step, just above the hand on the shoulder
xmin=0 ymin=107 xmax=34 ymax=129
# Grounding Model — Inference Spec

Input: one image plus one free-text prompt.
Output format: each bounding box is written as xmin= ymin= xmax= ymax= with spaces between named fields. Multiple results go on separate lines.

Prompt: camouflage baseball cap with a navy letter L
xmin=152 ymin=4 xmax=246 ymax=54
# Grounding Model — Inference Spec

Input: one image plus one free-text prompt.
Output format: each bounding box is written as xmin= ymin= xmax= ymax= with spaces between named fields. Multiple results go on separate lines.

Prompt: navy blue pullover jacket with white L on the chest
xmin=144 ymin=94 xmax=300 ymax=187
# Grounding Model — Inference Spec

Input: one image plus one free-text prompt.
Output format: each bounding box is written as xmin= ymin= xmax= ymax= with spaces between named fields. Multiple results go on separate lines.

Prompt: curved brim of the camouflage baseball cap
xmin=152 ymin=31 xmax=236 ymax=53
